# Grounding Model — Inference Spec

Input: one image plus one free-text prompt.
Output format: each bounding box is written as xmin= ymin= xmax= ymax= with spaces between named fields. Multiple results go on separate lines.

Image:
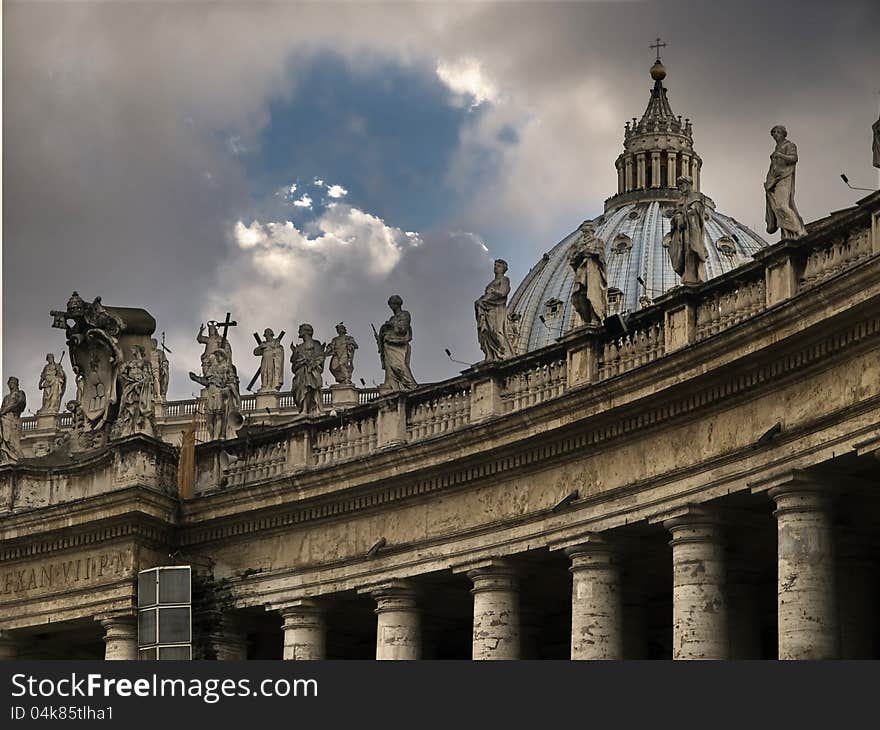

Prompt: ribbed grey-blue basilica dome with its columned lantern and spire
xmin=509 ymin=57 xmax=768 ymax=353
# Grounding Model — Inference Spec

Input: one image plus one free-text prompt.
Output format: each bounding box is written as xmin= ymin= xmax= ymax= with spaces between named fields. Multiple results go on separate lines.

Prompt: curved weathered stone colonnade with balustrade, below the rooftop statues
xmin=0 ymin=193 xmax=880 ymax=659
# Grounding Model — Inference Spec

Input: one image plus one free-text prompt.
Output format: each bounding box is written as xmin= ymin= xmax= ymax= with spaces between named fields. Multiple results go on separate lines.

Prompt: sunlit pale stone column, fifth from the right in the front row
xmin=370 ymin=581 xmax=422 ymax=660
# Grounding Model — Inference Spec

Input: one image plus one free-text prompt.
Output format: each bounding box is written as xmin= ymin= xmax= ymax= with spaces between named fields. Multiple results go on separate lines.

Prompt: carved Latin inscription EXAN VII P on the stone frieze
xmin=0 ymin=548 xmax=134 ymax=603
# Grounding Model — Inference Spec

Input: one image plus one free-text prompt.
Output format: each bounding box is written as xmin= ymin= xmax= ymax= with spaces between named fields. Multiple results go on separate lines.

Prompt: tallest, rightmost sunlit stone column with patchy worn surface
xmin=770 ymin=480 xmax=840 ymax=659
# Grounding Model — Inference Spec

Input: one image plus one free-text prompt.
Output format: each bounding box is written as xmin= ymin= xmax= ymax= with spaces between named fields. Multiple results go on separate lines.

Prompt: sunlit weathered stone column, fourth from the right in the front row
xmin=468 ymin=561 xmax=520 ymax=659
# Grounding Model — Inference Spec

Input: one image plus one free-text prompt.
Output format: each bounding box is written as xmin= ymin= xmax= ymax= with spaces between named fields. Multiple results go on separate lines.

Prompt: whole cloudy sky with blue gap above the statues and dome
xmin=2 ymin=0 xmax=880 ymax=410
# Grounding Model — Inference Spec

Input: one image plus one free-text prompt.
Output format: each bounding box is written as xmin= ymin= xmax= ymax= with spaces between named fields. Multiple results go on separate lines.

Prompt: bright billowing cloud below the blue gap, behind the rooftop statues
xmin=210 ymin=203 xmax=492 ymax=384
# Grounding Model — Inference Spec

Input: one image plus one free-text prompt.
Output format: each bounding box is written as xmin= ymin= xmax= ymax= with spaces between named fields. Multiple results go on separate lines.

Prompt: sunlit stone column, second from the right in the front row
xmin=663 ymin=507 xmax=728 ymax=659
